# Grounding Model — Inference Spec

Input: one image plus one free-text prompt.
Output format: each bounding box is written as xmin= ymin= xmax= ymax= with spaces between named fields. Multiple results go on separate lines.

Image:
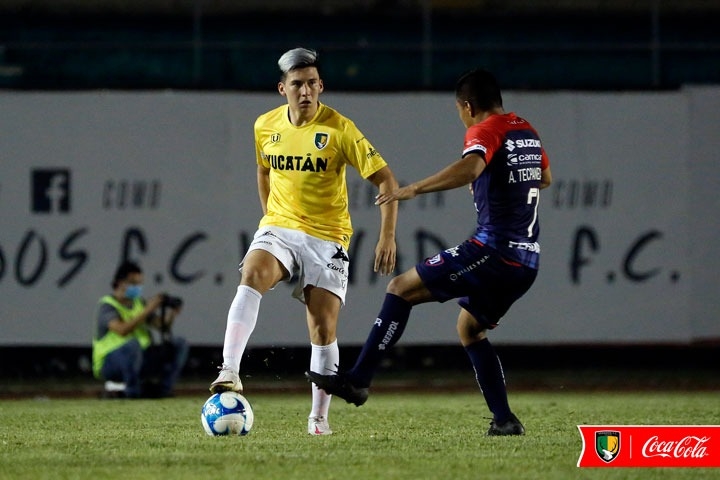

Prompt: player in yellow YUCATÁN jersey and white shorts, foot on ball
xmin=210 ymin=48 xmax=398 ymax=435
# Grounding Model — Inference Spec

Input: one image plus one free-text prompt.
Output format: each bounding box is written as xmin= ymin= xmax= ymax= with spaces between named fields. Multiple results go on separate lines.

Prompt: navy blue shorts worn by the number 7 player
xmin=415 ymin=240 xmax=537 ymax=329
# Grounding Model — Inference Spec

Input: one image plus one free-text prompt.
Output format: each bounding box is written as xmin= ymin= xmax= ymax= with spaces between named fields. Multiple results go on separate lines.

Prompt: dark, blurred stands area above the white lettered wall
xmin=0 ymin=2 xmax=720 ymax=91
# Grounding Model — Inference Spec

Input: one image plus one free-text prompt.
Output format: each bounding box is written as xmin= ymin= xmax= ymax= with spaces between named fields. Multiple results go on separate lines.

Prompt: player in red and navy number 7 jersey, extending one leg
xmin=306 ymin=69 xmax=552 ymax=435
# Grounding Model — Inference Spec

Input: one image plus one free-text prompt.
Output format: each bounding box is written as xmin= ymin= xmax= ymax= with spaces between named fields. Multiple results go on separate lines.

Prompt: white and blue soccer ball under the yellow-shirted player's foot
xmin=200 ymin=392 xmax=255 ymax=436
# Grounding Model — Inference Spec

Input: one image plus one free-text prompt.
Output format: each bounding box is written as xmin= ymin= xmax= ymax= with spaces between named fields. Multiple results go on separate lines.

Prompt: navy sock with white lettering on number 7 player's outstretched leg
xmin=347 ymin=293 xmax=412 ymax=387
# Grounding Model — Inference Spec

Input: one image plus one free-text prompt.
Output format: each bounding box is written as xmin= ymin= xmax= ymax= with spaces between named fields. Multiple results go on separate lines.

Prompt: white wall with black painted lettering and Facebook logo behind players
xmin=0 ymin=89 xmax=720 ymax=346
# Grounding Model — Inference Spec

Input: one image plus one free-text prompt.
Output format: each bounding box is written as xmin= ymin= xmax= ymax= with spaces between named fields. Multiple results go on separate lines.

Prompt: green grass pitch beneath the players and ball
xmin=0 ymin=391 xmax=720 ymax=480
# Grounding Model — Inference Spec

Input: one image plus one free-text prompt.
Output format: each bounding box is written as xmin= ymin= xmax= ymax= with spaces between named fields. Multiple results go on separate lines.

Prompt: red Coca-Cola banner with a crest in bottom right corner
xmin=577 ymin=425 xmax=720 ymax=467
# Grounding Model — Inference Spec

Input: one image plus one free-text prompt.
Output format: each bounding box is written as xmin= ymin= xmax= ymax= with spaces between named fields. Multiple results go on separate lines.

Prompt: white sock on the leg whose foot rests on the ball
xmin=223 ymin=285 xmax=262 ymax=371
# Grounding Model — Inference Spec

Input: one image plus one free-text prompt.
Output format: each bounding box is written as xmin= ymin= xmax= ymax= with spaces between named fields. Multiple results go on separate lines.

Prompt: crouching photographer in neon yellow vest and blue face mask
xmin=92 ymin=262 xmax=188 ymax=398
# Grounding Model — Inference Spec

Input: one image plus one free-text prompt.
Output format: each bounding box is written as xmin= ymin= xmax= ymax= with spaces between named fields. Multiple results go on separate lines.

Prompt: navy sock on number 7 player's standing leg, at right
xmin=465 ymin=338 xmax=511 ymax=424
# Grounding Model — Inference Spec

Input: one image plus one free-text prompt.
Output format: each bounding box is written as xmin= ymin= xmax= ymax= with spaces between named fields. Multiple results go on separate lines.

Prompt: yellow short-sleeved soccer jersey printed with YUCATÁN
xmin=255 ymin=104 xmax=387 ymax=249
